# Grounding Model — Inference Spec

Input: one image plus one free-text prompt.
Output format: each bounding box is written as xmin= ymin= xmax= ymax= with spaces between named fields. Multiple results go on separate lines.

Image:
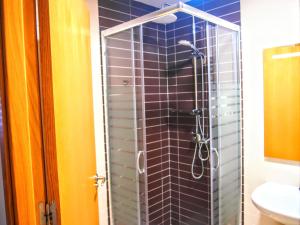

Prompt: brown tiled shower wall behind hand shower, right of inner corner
xmin=167 ymin=15 xmax=210 ymax=225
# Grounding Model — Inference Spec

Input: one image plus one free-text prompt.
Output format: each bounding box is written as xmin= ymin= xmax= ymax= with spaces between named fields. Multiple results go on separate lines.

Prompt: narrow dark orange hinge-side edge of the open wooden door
xmin=36 ymin=0 xmax=61 ymax=225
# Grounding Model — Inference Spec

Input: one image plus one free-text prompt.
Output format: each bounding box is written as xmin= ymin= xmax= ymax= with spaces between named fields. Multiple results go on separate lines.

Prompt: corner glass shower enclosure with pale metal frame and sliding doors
xmin=101 ymin=2 xmax=241 ymax=225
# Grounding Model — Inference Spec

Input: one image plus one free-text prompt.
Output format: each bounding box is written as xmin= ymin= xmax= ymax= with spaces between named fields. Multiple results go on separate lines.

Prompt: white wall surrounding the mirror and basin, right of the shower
xmin=241 ymin=0 xmax=300 ymax=225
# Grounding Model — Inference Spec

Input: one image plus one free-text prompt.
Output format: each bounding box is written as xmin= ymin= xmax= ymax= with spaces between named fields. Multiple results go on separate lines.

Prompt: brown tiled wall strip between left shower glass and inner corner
xmin=143 ymin=23 xmax=171 ymax=224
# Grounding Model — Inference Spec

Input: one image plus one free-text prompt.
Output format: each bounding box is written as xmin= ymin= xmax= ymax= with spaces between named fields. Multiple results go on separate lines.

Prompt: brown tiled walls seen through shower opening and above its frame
xmin=99 ymin=0 xmax=240 ymax=225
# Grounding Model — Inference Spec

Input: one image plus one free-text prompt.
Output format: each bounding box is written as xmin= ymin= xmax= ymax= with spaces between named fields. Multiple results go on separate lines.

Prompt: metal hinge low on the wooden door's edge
xmin=39 ymin=202 xmax=57 ymax=225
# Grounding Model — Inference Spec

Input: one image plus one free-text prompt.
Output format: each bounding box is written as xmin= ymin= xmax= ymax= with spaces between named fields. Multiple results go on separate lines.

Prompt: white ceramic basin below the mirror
xmin=251 ymin=182 xmax=300 ymax=225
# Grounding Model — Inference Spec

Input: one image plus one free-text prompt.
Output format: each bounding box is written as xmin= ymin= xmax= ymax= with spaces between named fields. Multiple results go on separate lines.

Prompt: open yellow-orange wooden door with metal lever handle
xmin=39 ymin=0 xmax=99 ymax=225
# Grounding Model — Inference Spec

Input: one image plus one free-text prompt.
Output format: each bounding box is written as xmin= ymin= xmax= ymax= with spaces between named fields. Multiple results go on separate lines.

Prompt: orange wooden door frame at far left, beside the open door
xmin=0 ymin=0 xmax=46 ymax=225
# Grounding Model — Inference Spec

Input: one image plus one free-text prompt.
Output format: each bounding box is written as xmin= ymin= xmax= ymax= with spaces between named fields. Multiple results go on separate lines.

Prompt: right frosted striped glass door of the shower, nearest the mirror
xmin=207 ymin=24 xmax=241 ymax=225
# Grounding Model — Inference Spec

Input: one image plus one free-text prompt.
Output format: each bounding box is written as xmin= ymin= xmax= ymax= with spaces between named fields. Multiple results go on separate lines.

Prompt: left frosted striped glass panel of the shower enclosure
xmin=106 ymin=28 xmax=145 ymax=225
